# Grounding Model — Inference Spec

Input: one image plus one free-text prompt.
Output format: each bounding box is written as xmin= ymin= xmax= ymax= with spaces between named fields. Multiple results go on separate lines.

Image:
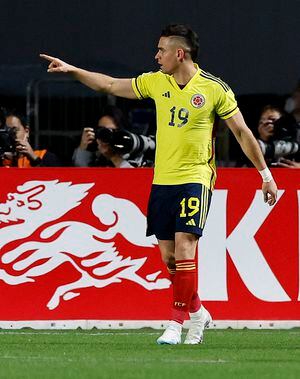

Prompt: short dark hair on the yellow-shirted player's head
xmin=160 ymin=24 xmax=199 ymax=61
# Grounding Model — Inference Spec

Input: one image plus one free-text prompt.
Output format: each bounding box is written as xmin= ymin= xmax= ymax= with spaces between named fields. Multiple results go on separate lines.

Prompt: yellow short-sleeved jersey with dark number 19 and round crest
xmin=132 ymin=65 xmax=238 ymax=189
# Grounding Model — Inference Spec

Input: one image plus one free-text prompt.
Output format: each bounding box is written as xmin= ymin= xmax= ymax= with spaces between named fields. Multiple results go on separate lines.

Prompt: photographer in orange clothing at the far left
xmin=0 ymin=109 xmax=61 ymax=168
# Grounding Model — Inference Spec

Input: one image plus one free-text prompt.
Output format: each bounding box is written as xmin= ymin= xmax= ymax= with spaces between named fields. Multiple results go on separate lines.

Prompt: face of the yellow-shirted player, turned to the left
xmin=155 ymin=37 xmax=179 ymax=74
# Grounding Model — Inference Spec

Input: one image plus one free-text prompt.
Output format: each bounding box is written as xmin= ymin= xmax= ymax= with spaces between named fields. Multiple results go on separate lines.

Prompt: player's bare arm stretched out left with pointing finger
xmin=40 ymin=54 xmax=137 ymax=99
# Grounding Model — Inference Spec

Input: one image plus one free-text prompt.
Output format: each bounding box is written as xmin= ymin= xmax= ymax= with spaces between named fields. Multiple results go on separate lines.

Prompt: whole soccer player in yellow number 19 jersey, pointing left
xmin=41 ymin=24 xmax=277 ymax=344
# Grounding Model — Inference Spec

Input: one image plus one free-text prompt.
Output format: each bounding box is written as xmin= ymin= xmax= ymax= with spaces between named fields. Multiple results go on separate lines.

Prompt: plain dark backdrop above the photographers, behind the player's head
xmin=0 ymin=0 xmax=300 ymax=96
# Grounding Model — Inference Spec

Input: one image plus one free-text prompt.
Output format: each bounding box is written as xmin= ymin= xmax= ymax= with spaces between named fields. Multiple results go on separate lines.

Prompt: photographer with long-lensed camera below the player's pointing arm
xmin=72 ymin=106 xmax=155 ymax=168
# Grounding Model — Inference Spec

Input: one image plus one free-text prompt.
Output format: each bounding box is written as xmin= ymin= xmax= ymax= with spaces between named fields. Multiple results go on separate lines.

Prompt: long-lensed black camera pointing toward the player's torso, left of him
xmin=95 ymin=126 xmax=155 ymax=158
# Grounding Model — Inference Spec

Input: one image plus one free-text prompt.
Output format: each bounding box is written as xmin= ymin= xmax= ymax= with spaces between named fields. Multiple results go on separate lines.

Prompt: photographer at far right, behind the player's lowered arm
xmin=257 ymin=105 xmax=300 ymax=167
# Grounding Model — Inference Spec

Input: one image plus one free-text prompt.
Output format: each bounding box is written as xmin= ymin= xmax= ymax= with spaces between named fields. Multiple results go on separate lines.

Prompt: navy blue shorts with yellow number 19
xmin=147 ymin=183 xmax=212 ymax=240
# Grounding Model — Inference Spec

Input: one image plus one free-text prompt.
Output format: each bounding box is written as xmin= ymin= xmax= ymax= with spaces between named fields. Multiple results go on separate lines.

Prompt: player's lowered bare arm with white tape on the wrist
xmin=225 ymin=112 xmax=277 ymax=205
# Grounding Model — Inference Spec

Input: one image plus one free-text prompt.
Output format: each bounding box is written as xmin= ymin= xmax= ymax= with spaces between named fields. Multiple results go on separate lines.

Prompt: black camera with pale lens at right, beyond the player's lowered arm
xmin=258 ymin=115 xmax=300 ymax=161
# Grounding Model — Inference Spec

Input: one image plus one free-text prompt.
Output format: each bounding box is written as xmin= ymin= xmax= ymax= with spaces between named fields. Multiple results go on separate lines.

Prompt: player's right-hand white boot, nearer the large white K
xmin=184 ymin=305 xmax=212 ymax=345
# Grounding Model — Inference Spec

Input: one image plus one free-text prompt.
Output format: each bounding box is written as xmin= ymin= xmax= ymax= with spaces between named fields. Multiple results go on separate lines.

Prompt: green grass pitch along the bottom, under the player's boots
xmin=0 ymin=329 xmax=300 ymax=379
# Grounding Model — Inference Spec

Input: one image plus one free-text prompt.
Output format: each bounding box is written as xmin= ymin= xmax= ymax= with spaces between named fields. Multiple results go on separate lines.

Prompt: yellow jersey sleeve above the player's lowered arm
xmin=216 ymin=86 xmax=239 ymax=120
